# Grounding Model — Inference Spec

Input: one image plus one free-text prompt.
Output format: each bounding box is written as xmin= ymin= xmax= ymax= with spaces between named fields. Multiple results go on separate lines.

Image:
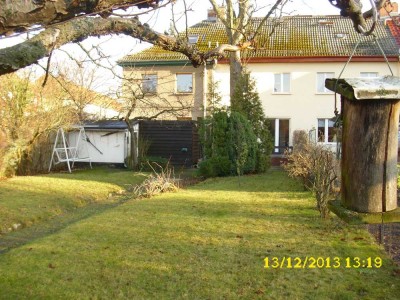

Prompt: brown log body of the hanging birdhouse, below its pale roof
xmin=341 ymin=96 xmax=400 ymax=212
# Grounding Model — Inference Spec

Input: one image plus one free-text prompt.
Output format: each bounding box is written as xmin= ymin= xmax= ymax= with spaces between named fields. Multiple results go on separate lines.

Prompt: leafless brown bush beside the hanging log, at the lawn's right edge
xmin=284 ymin=131 xmax=338 ymax=218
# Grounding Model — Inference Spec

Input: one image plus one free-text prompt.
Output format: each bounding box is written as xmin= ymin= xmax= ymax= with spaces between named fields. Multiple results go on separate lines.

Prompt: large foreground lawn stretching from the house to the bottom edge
xmin=0 ymin=171 xmax=400 ymax=299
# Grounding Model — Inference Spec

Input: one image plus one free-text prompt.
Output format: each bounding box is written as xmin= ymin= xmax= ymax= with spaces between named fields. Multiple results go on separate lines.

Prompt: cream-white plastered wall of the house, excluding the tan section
xmin=214 ymin=62 xmax=399 ymax=145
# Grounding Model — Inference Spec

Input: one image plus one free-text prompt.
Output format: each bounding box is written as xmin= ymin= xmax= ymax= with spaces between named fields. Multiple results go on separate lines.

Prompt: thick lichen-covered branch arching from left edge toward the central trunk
xmin=0 ymin=18 xmax=204 ymax=75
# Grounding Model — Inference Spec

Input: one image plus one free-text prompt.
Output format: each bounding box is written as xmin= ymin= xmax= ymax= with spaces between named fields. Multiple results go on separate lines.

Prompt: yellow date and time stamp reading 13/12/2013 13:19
xmin=264 ymin=256 xmax=383 ymax=269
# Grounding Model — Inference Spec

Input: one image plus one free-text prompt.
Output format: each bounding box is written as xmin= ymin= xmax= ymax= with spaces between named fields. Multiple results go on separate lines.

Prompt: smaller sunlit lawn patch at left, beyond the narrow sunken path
xmin=0 ymin=167 xmax=145 ymax=235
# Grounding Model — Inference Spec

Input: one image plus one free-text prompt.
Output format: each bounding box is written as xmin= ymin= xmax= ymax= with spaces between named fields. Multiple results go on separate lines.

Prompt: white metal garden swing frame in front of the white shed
xmin=49 ymin=127 xmax=92 ymax=173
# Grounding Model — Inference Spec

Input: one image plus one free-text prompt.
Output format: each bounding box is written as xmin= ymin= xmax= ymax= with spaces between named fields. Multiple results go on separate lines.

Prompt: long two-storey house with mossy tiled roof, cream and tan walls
xmin=119 ymin=11 xmax=399 ymax=154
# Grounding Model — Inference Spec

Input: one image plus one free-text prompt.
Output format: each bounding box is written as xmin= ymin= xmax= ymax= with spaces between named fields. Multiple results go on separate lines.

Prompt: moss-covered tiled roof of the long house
xmin=119 ymin=16 xmax=399 ymax=65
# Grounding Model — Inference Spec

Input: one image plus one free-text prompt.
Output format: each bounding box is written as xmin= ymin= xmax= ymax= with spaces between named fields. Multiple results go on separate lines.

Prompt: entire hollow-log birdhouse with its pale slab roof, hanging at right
xmin=326 ymin=76 xmax=400 ymax=213
